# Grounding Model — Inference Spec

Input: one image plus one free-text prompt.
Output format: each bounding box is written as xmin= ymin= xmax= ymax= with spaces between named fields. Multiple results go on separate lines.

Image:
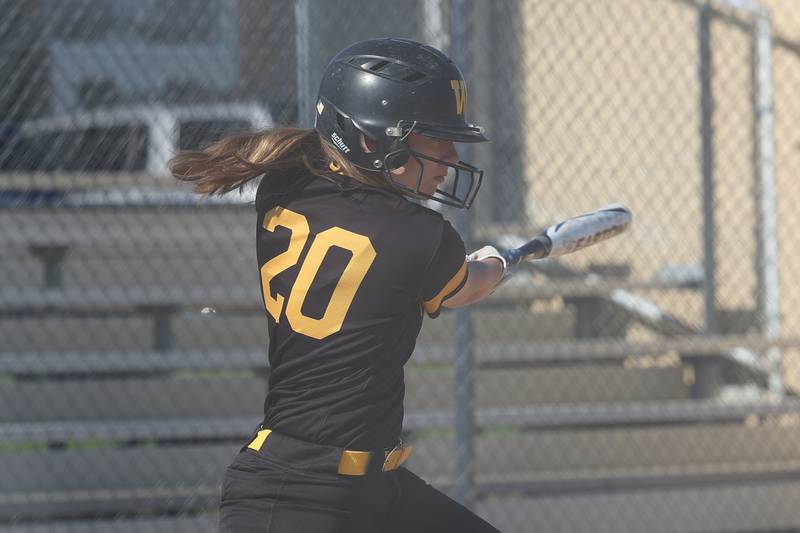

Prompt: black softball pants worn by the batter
xmin=220 ymin=433 xmax=499 ymax=533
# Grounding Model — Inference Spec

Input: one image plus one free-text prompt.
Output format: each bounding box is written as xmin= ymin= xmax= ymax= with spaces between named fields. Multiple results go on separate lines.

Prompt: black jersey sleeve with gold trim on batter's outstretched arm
xmin=422 ymin=220 xmax=467 ymax=318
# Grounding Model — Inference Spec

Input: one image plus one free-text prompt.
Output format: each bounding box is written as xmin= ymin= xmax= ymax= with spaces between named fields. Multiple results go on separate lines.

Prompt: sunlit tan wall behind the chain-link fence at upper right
xmin=520 ymin=0 xmax=800 ymax=384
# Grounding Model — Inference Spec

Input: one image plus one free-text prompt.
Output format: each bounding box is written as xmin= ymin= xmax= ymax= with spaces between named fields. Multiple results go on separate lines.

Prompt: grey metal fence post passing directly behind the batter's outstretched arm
xmin=450 ymin=0 xmax=475 ymax=506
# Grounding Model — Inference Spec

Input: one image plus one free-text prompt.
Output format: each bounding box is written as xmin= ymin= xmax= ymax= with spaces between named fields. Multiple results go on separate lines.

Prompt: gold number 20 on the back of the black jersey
xmin=261 ymin=207 xmax=376 ymax=339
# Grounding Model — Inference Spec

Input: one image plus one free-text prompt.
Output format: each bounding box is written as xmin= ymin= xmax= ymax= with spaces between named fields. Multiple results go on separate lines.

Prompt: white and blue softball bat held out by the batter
xmin=500 ymin=204 xmax=633 ymax=268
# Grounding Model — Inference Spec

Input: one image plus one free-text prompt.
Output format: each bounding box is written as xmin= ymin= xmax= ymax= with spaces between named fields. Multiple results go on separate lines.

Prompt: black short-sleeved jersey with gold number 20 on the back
xmin=256 ymin=177 xmax=467 ymax=449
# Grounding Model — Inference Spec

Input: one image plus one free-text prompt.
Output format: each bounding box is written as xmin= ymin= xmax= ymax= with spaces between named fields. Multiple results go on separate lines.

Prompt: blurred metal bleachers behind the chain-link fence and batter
xmin=0 ymin=200 xmax=800 ymax=533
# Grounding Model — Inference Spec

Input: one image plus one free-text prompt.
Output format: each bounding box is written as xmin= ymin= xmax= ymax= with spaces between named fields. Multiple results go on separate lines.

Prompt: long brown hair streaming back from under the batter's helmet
xmin=168 ymin=127 xmax=394 ymax=195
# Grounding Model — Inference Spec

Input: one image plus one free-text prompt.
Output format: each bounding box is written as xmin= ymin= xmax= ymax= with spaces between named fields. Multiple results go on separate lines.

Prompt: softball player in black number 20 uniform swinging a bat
xmin=171 ymin=39 xmax=505 ymax=533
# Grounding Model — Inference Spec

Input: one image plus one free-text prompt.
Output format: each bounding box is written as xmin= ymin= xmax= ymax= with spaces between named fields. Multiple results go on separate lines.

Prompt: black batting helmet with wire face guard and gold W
xmin=315 ymin=39 xmax=488 ymax=208
